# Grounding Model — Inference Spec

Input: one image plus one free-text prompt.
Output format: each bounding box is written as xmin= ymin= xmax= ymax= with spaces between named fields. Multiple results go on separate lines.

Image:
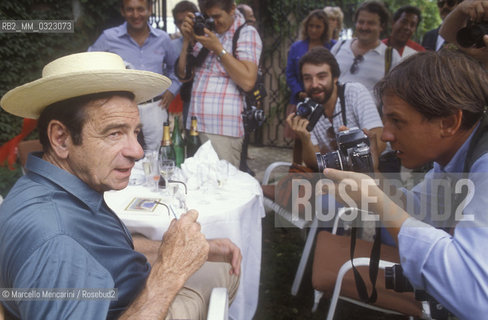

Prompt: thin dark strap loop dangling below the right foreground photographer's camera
xmin=350 ymin=227 xmax=381 ymax=303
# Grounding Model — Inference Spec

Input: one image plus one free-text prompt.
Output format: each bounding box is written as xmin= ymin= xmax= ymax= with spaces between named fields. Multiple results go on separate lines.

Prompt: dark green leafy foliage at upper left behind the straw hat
xmin=0 ymin=0 xmax=121 ymax=195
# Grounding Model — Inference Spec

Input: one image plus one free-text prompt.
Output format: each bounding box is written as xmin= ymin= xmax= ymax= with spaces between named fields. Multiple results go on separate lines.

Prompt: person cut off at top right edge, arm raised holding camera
xmin=439 ymin=0 xmax=488 ymax=69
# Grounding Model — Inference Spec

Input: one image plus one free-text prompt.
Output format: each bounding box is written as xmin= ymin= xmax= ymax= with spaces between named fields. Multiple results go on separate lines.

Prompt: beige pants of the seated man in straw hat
xmin=166 ymin=262 xmax=239 ymax=320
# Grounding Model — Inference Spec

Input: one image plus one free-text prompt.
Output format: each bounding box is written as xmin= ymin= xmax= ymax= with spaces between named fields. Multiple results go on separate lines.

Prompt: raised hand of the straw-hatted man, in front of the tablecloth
xmin=157 ymin=210 xmax=209 ymax=281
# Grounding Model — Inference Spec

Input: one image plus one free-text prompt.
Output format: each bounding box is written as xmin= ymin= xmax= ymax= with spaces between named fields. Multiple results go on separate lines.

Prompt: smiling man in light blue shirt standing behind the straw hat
xmin=88 ymin=0 xmax=181 ymax=150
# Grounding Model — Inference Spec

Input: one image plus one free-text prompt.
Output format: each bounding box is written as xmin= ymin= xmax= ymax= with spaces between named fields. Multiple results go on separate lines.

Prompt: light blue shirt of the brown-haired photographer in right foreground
xmin=398 ymin=126 xmax=488 ymax=319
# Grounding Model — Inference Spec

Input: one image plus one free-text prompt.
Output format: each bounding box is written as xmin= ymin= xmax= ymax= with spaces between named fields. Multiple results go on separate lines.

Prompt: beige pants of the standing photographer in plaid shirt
xmin=199 ymin=132 xmax=244 ymax=169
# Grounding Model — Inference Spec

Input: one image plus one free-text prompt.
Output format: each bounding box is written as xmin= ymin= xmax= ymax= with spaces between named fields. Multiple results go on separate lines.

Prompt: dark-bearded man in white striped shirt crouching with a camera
xmin=286 ymin=47 xmax=385 ymax=170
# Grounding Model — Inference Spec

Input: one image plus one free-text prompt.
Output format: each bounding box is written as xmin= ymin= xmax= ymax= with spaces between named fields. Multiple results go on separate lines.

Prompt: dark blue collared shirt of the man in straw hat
xmin=0 ymin=154 xmax=150 ymax=319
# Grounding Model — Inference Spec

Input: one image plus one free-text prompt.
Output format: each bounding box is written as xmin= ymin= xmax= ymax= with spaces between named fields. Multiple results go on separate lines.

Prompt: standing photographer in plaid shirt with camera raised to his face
xmin=176 ymin=0 xmax=262 ymax=168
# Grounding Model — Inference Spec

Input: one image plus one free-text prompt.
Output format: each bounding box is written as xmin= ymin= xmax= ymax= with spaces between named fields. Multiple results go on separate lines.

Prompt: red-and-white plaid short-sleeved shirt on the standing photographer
xmin=186 ymin=10 xmax=262 ymax=137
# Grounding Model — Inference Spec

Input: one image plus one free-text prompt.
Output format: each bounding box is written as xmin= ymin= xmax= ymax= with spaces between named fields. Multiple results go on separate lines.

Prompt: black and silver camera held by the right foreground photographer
xmin=315 ymin=128 xmax=373 ymax=173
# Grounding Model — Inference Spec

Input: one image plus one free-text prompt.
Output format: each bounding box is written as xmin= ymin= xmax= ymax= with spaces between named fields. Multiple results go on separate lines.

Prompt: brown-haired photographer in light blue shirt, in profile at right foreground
xmin=324 ymin=50 xmax=488 ymax=319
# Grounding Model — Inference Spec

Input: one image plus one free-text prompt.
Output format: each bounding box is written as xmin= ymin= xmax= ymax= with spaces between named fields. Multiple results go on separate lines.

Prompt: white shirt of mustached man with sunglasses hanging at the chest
xmin=330 ymin=39 xmax=400 ymax=96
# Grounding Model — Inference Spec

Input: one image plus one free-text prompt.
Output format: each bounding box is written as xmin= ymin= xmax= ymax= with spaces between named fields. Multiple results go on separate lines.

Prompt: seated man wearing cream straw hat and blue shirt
xmin=0 ymin=52 xmax=241 ymax=319
